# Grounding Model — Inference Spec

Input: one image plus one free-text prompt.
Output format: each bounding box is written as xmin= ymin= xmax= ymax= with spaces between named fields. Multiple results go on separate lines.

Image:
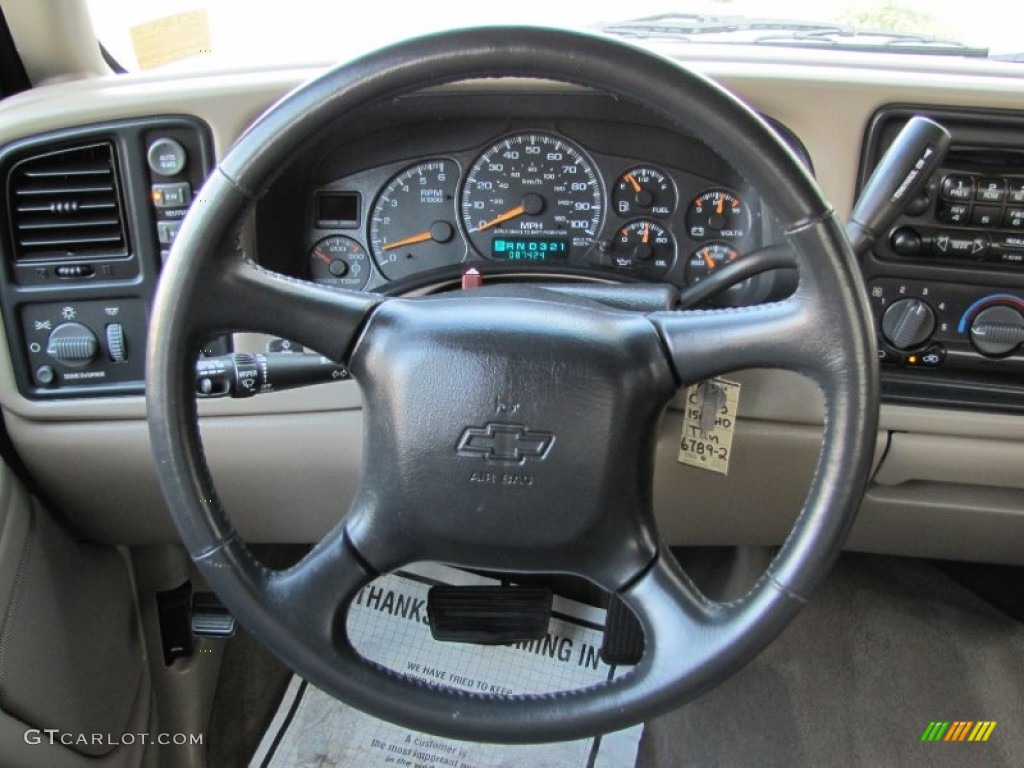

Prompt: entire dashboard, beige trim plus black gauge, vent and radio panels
xmin=0 ymin=52 xmax=1024 ymax=562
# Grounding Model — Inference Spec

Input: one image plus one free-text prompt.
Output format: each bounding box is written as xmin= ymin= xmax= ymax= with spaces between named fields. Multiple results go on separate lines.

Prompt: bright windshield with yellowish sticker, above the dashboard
xmin=88 ymin=0 xmax=1024 ymax=71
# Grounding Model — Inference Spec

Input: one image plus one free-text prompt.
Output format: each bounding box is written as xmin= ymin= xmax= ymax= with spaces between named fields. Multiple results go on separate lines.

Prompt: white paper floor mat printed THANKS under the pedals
xmin=250 ymin=564 xmax=643 ymax=768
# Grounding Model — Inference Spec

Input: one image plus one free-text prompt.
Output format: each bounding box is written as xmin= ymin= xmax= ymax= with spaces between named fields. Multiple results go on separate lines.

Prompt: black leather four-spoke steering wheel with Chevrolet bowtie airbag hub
xmin=146 ymin=28 xmax=878 ymax=743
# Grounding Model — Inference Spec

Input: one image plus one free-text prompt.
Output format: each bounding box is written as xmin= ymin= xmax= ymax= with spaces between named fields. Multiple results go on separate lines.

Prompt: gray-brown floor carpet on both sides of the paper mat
xmin=208 ymin=555 xmax=1024 ymax=768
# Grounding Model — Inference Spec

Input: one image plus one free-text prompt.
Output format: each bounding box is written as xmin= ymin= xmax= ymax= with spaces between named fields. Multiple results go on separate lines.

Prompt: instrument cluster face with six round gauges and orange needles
xmin=299 ymin=128 xmax=766 ymax=304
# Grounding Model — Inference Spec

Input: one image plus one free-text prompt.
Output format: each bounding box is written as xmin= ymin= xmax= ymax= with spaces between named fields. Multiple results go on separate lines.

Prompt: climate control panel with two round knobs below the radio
xmin=868 ymin=278 xmax=1024 ymax=374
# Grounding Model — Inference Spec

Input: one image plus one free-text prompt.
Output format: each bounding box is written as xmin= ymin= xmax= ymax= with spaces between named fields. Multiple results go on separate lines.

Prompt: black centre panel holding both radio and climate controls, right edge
xmin=861 ymin=106 xmax=1024 ymax=411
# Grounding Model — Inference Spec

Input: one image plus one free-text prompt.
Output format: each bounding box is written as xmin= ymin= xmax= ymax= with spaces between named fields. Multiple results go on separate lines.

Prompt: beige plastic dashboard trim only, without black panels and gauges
xmin=0 ymin=49 xmax=1024 ymax=563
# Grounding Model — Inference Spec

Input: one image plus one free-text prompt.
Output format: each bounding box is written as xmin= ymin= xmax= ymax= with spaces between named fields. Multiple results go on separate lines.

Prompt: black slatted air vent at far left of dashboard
xmin=7 ymin=141 xmax=128 ymax=260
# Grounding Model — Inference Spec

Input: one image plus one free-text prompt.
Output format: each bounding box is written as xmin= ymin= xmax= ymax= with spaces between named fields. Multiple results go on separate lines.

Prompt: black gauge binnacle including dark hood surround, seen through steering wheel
xmin=255 ymin=93 xmax=799 ymax=305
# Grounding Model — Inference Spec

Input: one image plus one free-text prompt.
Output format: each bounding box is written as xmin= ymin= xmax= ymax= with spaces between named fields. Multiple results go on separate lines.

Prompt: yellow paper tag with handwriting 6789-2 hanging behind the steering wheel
xmin=679 ymin=379 xmax=739 ymax=475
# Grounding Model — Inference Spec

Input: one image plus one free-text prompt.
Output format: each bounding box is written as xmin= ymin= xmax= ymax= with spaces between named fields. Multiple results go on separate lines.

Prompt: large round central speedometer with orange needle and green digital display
xmin=462 ymin=133 xmax=604 ymax=262
